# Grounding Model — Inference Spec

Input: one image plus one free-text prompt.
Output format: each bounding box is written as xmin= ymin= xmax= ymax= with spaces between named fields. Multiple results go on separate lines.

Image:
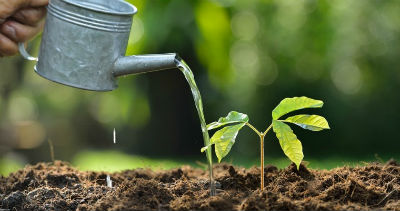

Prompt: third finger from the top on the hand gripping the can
xmin=0 ymin=21 xmax=44 ymax=42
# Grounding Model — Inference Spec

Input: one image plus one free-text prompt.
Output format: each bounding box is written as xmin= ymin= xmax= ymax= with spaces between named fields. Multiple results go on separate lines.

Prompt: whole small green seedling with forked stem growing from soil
xmin=201 ymin=97 xmax=330 ymax=190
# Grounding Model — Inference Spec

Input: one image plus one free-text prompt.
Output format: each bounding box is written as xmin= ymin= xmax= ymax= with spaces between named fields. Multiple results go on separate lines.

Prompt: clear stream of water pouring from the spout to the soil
xmin=176 ymin=59 xmax=215 ymax=196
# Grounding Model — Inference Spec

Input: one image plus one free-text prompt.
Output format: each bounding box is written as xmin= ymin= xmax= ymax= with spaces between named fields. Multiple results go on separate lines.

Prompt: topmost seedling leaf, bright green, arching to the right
xmin=272 ymin=97 xmax=324 ymax=120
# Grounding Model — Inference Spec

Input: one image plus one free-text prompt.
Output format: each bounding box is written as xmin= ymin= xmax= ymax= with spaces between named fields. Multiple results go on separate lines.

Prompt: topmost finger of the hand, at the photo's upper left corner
xmin=0 ymin=0 xmax=49 ymax=20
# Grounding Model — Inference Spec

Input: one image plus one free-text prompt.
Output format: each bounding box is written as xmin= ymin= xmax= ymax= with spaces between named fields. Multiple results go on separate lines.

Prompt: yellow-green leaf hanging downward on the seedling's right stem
xmin=272 ymin=120 xmax=304 ymax=169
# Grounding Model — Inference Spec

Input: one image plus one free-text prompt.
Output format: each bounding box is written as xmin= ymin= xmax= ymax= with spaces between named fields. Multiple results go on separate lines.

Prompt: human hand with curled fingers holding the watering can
xmin=0 ymin=0 xmax=49 ymax=57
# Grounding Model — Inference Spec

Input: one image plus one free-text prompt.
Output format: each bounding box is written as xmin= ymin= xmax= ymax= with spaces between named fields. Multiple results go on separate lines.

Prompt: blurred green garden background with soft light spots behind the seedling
xmin=0 ymin=0 xmax=400 ymax=174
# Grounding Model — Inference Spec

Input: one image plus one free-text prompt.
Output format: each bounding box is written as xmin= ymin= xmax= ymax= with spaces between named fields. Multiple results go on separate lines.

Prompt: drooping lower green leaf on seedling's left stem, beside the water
xmin=210 ymin=123 xmax=246 ymax=162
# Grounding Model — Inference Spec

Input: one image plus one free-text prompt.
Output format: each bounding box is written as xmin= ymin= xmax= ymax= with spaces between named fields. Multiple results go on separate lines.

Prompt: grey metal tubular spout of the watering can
xmin=113 ymin=53 xmax=180 ymax=77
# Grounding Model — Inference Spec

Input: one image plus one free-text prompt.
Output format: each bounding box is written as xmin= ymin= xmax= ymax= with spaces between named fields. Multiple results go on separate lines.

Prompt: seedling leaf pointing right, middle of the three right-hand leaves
xmin=284 ymin=114 xmax=330 ymax=131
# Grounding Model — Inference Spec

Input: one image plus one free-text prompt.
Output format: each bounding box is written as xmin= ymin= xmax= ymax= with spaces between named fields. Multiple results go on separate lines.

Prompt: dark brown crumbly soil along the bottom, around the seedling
xmin=0 ymin=161 xmax=400 ymax=210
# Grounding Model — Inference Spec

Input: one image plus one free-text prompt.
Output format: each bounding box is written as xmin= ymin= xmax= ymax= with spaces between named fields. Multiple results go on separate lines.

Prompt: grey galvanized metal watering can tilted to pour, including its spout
xmin=19 ymin=0 xmax=179 ymax=91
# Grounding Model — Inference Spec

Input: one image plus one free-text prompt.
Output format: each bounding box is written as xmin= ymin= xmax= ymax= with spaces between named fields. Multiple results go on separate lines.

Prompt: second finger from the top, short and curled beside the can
xmin=12 ymin=7 xmax=46 ymax=26
